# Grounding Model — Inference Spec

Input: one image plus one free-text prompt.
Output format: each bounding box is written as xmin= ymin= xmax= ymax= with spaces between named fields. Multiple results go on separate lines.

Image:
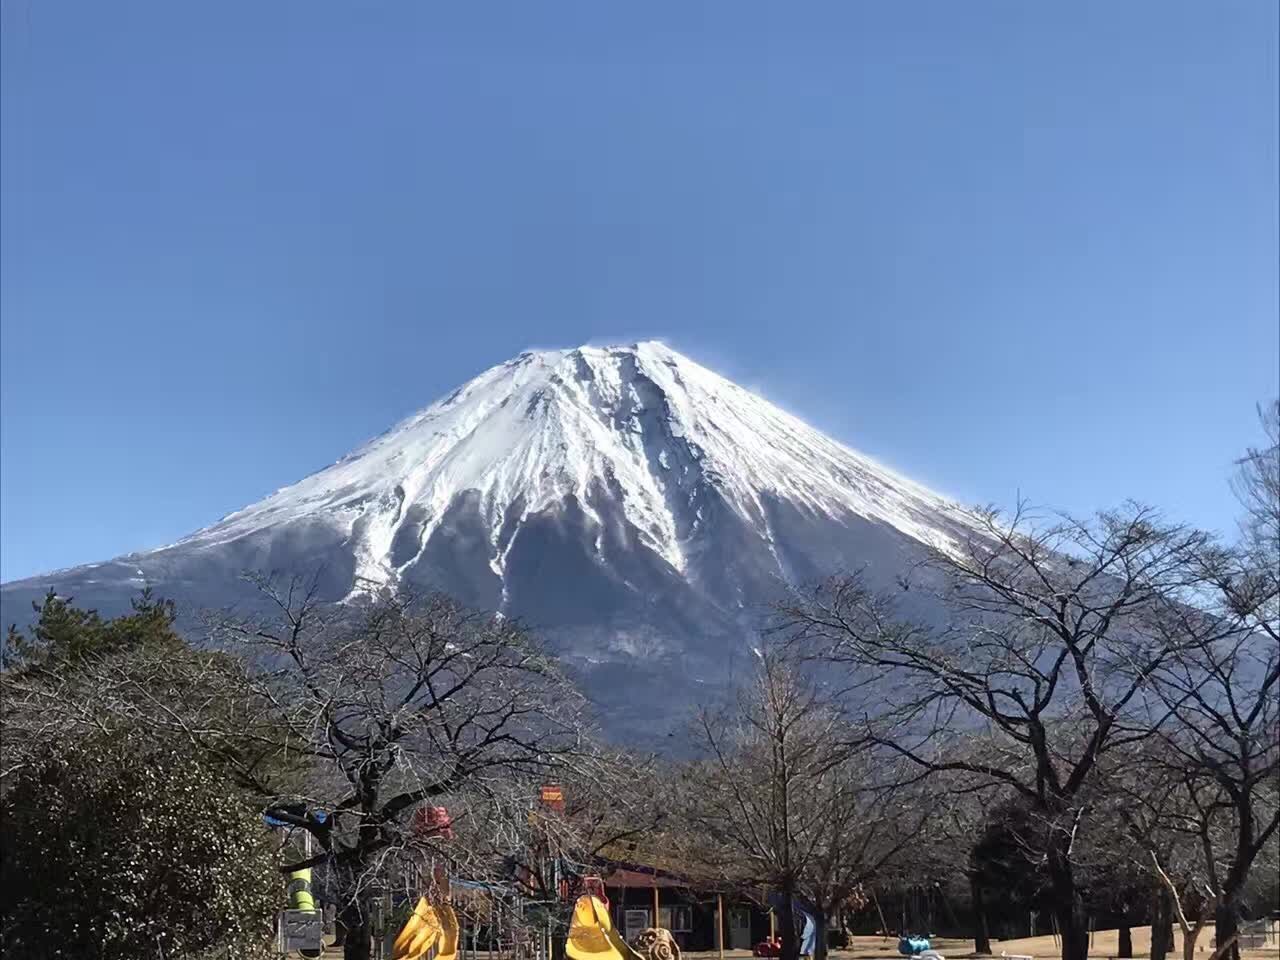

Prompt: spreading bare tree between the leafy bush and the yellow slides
xmin=194 ymin=579 xmax=585 ymax=960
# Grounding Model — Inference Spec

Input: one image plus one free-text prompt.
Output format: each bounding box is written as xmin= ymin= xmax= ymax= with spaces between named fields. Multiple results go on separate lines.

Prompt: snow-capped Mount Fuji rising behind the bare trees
xmin=0 ymin=342 xmax=966 ymax=732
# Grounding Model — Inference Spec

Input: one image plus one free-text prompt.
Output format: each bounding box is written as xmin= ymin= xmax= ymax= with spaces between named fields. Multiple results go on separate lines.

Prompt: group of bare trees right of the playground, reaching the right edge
xmin=701 ymin=404 xmax=1280 ymax=960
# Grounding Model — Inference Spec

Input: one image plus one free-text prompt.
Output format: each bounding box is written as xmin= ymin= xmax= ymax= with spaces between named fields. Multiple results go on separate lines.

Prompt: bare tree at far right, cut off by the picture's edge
xmin=1156 ymin=402 xmax=1280 ymax=957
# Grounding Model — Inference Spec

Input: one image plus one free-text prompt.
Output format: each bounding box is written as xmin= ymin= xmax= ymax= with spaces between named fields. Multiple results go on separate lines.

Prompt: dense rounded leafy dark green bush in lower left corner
xmin=0 ymin=735 xmax=280 ymax=960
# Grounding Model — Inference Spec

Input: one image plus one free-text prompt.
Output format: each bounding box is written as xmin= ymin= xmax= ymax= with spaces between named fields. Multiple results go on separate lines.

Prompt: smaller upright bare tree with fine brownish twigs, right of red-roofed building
xmin=686 ymin=650 xmax=925 ymax=959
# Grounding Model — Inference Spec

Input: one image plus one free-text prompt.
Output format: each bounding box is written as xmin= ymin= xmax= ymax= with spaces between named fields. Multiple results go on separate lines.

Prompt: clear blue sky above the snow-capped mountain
xmin=0 ymin=0 xmax=1280 ymax=579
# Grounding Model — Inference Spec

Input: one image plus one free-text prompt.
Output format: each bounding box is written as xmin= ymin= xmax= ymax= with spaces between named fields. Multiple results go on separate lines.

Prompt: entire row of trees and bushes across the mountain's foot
xmin=0 ymin=406 xmax=1280 ymax=960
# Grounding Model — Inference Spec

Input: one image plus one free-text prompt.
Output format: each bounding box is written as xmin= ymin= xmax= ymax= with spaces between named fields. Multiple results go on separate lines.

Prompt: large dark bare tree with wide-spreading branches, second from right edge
xmin=781 ymin=507 xmax=1229 ymax=960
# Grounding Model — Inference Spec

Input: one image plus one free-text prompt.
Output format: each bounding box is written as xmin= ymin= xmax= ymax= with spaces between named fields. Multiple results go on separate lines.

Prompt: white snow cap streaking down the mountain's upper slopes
xmin=175 ymin=342 xmax=950 ymax=584
